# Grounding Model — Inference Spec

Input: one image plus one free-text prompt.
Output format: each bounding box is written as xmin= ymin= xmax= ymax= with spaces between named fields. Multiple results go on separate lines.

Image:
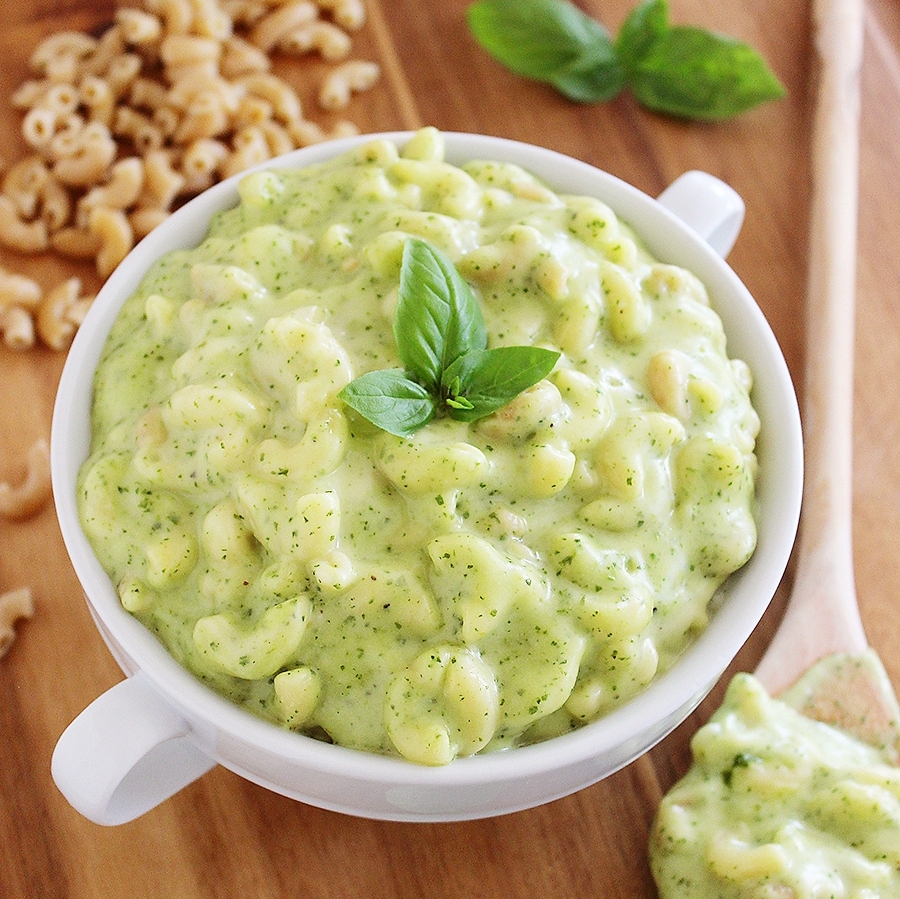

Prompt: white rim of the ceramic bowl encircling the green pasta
xmin=50 ymin=131 xmax=803 ymax=786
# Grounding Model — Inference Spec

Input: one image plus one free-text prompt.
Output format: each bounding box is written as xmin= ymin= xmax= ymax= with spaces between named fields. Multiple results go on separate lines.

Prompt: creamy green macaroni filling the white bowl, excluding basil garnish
xmin=79 ymin=129 xmax=759 ymax=764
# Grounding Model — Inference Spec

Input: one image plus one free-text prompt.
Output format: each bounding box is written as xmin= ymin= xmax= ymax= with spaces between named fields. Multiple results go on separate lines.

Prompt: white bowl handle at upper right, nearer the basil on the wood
xmin=656 ymin=171 xmax=744 ymax=259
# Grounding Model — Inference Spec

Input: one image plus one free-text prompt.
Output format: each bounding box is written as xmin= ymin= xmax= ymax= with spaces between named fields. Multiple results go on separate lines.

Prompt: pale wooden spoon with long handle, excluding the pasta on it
xmin=756 ymin=0 xmax=900 ymax=761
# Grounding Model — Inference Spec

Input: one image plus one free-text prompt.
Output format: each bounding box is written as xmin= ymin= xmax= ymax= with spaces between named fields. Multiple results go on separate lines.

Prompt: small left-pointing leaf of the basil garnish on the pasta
xmin=338 ymin=369 xmax=435 ymax=437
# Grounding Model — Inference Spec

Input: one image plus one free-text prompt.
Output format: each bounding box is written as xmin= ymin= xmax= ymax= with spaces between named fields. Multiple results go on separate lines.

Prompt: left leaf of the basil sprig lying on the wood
xmin=466 ymin=0 xmax=624 ymax=102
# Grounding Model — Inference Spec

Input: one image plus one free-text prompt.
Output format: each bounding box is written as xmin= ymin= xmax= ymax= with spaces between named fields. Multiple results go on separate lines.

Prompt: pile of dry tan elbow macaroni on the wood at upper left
xmin=0 ymin=0 xmax=379 ymax=349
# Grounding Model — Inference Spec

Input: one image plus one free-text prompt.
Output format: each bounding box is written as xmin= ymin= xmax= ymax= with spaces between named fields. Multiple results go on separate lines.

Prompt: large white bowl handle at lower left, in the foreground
xmin=51 ymin=672 xmax=215 ymax=825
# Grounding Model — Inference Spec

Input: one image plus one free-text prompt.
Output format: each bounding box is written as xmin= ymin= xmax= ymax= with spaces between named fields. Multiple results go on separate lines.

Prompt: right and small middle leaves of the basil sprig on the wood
xmin=617 ymin=0 xmax=785 ymax=121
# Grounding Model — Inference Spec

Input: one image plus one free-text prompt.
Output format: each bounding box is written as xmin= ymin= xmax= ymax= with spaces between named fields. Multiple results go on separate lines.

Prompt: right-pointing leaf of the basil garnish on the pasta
xmin=442 ymin=346 xmax=559 ymax=421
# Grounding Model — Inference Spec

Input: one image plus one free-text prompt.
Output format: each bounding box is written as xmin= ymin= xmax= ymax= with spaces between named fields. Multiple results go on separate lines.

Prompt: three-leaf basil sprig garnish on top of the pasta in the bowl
xmin=338 ymin=238 xmax=559 ymax=437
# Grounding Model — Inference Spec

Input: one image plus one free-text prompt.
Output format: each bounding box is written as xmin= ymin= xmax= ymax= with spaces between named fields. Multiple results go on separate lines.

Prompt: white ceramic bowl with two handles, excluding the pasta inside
xmin=51 ymin=133 xmax=802 ymax=824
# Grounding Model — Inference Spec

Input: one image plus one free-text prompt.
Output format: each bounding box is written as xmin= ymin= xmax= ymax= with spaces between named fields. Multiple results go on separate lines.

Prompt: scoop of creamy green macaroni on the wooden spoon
xmin=650 ymin=674 xmax=900 ymax=899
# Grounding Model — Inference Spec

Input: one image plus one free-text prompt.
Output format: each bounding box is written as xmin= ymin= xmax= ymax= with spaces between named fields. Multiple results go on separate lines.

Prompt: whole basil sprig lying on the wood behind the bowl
xmin=467 ymin=0 xmax=785 ymax=121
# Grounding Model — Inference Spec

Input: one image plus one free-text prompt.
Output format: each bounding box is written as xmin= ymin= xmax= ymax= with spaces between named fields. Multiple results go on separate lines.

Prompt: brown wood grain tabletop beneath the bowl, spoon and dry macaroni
xmin=0 ymin=0 xmax=900 ymax=899
